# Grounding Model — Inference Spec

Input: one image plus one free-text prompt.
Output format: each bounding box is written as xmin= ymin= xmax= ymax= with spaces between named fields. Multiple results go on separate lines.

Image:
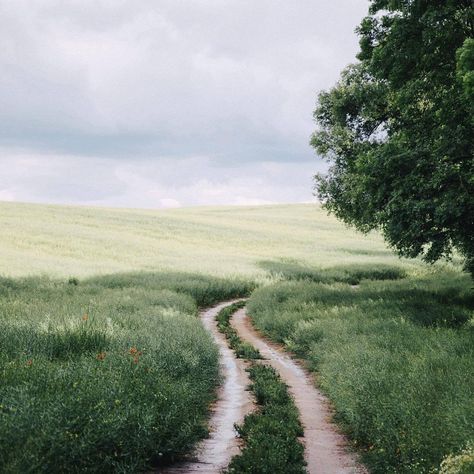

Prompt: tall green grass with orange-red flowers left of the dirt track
xmin=0 ymin=273 xmax=252 ymax=473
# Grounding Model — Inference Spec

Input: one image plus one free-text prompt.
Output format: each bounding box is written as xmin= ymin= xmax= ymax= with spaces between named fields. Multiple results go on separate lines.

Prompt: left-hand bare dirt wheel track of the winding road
xmin=158 ymin=300 xmax=254 ymax=474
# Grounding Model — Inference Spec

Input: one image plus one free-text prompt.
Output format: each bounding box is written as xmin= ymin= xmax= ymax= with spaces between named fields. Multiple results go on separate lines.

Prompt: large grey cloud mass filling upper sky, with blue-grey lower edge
xmin=0 ymin=0 xmax=367 ymax=161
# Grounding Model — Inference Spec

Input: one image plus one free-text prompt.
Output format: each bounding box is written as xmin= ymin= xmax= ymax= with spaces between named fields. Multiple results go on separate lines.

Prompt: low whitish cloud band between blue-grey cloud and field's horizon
xmin=0 ymin=149 xmax=316 ymax=208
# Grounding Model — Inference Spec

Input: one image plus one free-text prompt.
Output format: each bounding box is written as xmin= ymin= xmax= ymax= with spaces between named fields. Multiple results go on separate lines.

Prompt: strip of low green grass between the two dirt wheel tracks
xmin=216 ymin=302 xmax=306 ymax=474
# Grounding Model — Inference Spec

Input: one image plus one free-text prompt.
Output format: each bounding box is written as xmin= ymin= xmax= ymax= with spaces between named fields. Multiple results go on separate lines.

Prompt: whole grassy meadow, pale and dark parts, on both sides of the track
xmin=0 ymin=203 xmax=474 ymax=474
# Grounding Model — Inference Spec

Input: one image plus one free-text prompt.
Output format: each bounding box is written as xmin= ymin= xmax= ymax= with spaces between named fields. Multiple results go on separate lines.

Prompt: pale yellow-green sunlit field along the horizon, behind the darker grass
xmin=0 ymin=202 xmax=420 ymax=277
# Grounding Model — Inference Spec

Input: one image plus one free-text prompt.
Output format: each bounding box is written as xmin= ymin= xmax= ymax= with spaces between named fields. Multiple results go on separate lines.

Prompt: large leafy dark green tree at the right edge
xmin=311 ymin=0 xmax=474 ymax=274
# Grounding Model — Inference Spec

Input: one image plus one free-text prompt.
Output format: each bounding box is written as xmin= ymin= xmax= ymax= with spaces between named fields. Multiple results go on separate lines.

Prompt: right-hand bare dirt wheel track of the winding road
xmin=231 ymin=308 xmax=367 ymax=474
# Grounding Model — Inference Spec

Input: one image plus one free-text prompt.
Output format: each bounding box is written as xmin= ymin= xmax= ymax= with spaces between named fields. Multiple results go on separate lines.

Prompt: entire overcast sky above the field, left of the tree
xmin=0 ymin=0 xmax=368 ymax=208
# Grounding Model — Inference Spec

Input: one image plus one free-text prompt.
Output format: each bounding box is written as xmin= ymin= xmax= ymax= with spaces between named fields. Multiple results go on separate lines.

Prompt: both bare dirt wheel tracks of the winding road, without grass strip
xmin=163 ymin=301 xmax=367 ymax=474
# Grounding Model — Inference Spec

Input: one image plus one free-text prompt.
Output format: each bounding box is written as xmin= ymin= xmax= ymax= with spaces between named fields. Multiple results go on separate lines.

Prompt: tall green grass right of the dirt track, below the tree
xmin=247 ymin=272 xmax=474 ymax=474
